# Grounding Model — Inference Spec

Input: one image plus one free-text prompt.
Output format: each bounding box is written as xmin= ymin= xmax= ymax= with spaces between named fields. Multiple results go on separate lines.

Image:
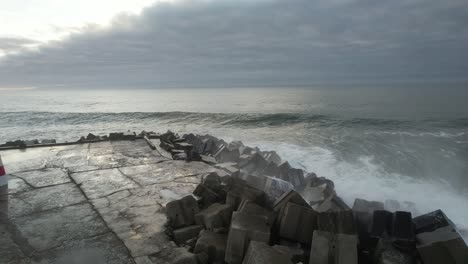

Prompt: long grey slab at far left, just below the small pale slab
xmin=8 ymin=183 xmax=86 ymax=217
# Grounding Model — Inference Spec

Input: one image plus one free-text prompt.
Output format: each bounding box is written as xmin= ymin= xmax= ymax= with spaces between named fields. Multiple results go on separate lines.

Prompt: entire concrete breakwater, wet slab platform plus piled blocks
xmin=0 ymin=132 xmax=467 ymax=264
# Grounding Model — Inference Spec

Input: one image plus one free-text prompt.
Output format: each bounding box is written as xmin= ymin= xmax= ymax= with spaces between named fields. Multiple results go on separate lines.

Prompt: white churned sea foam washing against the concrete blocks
xmin=259 ymin=142 xmax=468 ymax=241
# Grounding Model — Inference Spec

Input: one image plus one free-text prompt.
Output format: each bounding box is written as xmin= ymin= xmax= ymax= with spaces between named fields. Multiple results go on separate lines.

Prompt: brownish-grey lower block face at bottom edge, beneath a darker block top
xmin=309 ymin=230 xmax=358 ymax=264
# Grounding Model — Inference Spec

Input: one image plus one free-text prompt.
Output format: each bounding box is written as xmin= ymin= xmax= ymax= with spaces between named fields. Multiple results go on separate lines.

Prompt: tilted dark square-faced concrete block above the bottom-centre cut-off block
xmin=279 ymin=203 xmax=318 ymax=244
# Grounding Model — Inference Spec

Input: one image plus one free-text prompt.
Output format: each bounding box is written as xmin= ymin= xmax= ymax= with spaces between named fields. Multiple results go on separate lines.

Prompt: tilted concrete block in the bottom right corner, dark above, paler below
xmin=413 ymin=210 xmax=468 ymax=264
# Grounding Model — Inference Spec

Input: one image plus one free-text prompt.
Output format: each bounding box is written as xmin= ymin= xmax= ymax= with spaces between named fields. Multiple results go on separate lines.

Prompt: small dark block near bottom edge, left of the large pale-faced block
xmin=193 ymin=230 xmax=227 ymax=263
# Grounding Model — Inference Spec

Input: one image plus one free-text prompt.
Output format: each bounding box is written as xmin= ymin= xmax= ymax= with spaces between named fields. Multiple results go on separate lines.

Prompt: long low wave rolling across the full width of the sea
xmin=0 ymin=112 xmax=468 ymax=130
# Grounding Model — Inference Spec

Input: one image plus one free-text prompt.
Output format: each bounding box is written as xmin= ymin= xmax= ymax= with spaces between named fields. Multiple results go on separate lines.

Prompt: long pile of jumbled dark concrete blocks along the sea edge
xmin=160 ymin=131 xmax=468 ymax=264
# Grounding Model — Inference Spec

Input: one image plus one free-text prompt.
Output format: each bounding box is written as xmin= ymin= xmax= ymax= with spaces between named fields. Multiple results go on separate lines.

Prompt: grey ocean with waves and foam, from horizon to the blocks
xmin=0 ymin=86 xmax=468 ymax=237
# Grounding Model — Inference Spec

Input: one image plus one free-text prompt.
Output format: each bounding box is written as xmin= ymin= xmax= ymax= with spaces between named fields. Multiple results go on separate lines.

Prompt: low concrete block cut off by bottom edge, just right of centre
xmin=242 ymin=241 xmax=293 ymax=264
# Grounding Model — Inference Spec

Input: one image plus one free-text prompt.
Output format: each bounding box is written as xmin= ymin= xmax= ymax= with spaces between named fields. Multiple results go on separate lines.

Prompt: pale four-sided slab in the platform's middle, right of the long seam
xmin=71 ymin=169 xmax=138 ymax=199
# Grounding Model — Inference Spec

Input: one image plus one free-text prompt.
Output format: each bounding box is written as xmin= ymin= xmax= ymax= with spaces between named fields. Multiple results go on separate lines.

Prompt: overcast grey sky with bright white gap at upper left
xmin=0 ymin=0 xmax=468 ymax=88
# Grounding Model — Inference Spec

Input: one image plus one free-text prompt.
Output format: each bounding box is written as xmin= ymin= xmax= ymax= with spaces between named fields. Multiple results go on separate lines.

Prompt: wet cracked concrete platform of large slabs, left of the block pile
xmin=0 ymin=140 xmax=217 ymax=264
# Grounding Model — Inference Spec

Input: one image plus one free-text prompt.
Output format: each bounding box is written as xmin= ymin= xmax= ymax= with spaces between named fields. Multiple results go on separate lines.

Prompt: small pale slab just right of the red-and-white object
xmin=14 ymin=168 xmax=70 ymax=188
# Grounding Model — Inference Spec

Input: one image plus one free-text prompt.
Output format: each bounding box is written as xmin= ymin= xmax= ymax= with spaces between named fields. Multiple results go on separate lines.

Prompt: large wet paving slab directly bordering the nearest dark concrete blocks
xmin=92 ymin=183 xmax=194 ymax=257
